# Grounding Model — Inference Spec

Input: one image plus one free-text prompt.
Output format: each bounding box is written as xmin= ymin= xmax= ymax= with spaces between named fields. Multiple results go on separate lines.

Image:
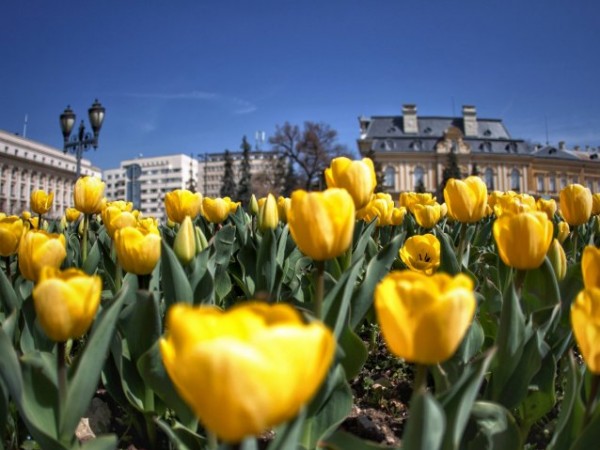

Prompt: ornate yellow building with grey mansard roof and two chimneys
xmin=358 ymin=105 xmax=600 ymax=197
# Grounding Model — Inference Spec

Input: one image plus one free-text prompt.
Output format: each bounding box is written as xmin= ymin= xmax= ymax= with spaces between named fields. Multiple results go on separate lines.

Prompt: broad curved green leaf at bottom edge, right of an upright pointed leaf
xmin=467 ymin=401 xmax=522 ymax=450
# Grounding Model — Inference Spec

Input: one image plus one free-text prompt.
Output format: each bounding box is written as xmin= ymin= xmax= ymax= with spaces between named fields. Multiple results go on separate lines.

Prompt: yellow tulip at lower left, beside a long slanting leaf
xmin=32 ymin=266 xmax=102 ymax=342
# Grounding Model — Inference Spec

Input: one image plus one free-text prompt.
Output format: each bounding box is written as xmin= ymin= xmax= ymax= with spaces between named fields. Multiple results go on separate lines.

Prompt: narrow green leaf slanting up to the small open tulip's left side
xmin=350 ymin=234 xmax=404 ymax=329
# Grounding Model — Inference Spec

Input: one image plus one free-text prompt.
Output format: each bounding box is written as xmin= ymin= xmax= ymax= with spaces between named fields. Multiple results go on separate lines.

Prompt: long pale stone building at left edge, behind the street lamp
xmin=0 ymin=130 xmax=101 ymax=218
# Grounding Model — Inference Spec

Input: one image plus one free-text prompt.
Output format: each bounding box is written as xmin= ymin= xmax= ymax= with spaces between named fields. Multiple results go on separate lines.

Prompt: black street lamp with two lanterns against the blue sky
xmin=60 ymin=99 xmax=105 ymax=178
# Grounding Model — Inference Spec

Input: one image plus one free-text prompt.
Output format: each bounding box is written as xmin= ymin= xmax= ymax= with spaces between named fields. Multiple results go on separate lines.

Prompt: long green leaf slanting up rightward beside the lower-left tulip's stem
xmin=60 ymin=288 xmax=130 ymax=438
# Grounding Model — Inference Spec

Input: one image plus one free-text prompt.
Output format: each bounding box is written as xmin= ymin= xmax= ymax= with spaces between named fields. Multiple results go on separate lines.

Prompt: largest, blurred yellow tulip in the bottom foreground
xmin=160 ymin=302 xmax=335 ymax=443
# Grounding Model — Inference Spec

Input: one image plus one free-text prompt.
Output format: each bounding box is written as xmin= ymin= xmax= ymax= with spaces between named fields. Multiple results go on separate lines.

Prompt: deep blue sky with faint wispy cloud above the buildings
xmin=0 ymin=0 xmax=600 ymax=169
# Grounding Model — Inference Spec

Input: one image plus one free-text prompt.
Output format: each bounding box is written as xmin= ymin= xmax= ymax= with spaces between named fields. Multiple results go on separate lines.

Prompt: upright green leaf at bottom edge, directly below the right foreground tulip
xmin=402 ymin=392 xmax=446 ymax=450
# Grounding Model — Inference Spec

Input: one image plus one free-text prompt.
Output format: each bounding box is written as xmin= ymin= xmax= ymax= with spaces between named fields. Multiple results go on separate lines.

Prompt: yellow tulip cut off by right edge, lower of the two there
xmin=571 ymin=287 xmax=600 ymax=375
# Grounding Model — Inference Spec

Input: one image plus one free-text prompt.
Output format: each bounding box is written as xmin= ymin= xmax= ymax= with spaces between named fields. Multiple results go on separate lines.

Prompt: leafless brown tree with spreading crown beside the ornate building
xmin=269 ymin=121 xmax=351 ymax=190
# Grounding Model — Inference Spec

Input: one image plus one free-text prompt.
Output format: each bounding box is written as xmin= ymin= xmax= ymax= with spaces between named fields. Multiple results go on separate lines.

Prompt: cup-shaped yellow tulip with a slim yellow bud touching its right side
xmin=493 ymin=211 xmax=554 ymax=269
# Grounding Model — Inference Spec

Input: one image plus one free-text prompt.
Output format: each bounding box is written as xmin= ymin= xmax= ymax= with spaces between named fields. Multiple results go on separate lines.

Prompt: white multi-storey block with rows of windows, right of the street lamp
xmin=103 ymin=154 xmax=200 ymax=221
